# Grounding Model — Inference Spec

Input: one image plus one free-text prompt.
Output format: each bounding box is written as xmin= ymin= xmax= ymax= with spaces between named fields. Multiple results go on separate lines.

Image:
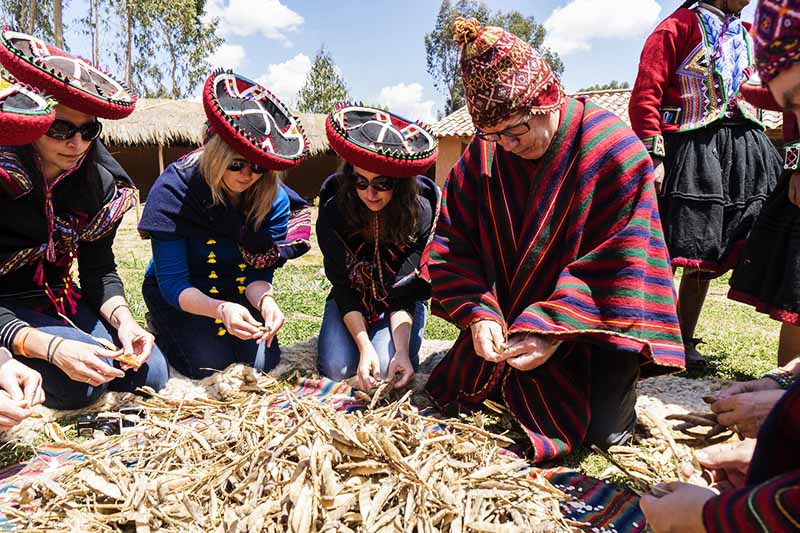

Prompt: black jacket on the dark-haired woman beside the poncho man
xmin=317 ymin=175 xmax=440 ymax=325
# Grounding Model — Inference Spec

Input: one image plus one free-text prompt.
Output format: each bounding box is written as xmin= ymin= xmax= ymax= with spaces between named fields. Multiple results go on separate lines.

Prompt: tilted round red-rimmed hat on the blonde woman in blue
xmin=203 ymin=70 xmax=309 ymax=170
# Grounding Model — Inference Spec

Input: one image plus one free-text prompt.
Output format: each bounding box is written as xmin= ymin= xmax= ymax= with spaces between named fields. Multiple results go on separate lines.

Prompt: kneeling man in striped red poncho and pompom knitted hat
xmin=426 ymin=19 xmax=684 ymax=461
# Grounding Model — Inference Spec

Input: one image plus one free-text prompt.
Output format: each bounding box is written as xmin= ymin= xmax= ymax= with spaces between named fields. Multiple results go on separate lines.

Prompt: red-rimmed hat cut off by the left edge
xmin=0 ymin=68 xmax=56 ymax=144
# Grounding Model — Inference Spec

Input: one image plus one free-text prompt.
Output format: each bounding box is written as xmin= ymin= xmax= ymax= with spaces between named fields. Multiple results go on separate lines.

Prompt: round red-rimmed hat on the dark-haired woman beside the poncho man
xmin=325 ymin=102 xmax=439 ymax=178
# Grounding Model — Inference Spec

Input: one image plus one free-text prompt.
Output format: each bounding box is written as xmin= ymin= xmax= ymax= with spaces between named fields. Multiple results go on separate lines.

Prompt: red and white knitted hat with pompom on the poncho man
xmin=453 ymin=17 xmax=564 ymax=128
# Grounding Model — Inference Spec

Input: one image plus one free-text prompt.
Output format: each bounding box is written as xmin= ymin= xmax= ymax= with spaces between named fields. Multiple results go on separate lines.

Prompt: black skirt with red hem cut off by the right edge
xmin=728 ymin=170 xmax=800 ymax=326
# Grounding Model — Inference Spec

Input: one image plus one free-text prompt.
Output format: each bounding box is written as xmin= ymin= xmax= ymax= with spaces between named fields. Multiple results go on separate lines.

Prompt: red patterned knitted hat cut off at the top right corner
xmin=755 ymin=0 xmax=800 ymax=82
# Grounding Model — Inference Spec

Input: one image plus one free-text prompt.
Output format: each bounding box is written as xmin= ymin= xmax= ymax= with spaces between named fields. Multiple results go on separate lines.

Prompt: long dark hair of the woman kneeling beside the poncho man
xmin=336 ymin=162 xmax=422 ymax=246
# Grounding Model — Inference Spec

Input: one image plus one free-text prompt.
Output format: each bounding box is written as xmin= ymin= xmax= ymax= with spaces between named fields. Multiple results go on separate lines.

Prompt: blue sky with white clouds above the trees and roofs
xmin=68 ymin=0 xmax=755 ymax=120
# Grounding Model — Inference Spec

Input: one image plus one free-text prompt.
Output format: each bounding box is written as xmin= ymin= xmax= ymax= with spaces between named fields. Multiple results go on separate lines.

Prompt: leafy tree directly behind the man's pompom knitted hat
xmin=425 ymin=0 xmax=564 ymax=115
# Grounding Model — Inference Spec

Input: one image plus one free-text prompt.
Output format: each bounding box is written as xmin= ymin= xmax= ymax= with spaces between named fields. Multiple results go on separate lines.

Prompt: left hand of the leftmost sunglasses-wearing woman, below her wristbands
xmin=52 ymin=339 xmax=125 ymax=387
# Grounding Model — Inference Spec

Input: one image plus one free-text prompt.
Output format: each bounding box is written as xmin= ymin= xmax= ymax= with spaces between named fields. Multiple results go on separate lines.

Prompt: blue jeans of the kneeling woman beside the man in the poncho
xmin=317 ymin=298 xmax=428 ymax=381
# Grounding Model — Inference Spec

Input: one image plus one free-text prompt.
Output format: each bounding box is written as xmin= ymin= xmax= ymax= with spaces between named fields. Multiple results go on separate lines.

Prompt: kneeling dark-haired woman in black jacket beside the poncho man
xmin=317 ymin=104 xmax=439 ymax=390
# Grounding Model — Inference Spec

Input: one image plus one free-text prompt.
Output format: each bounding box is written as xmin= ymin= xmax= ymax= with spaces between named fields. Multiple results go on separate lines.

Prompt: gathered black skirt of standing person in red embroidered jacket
xmin=658 ymin=121 xmax=783 ymax=277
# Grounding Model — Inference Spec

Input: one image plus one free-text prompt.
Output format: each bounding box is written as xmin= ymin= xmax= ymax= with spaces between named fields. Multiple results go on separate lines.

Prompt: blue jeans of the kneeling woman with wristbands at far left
xmin=3 ymin=301 xmax=169 ymax=409
